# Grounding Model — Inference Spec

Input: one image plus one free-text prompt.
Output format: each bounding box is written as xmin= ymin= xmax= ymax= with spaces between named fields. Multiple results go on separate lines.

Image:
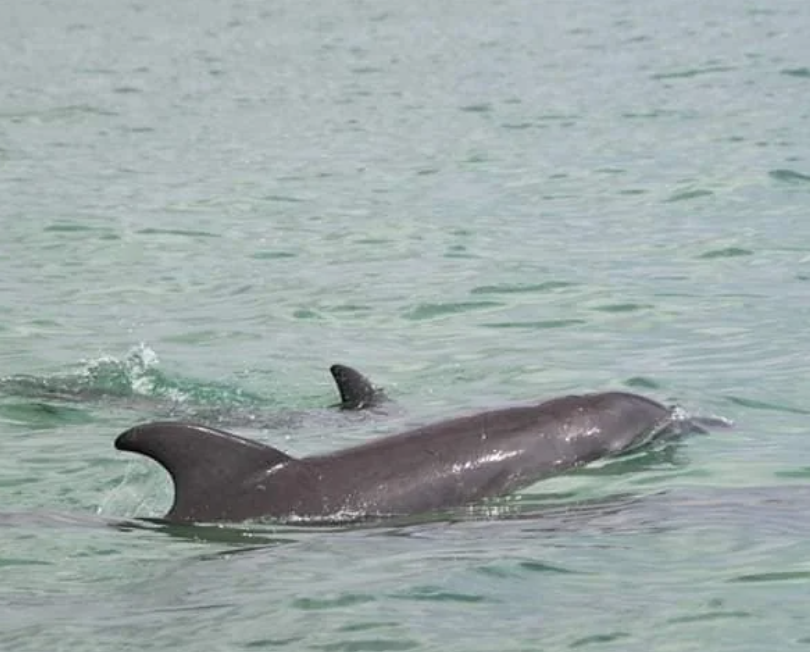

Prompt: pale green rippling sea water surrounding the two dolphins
xmin=0 ymin=0 xmax=810 ymax=652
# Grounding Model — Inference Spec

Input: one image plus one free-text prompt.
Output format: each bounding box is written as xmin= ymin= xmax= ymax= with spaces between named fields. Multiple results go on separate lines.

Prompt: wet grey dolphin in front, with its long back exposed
xmin=115 ymin=392 xmax=722 ymax=522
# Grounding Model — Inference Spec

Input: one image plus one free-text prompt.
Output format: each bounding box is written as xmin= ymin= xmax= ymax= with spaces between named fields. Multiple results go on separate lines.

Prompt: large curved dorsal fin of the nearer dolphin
xmin=115 ymin=421 xmax=293 ymax=521
